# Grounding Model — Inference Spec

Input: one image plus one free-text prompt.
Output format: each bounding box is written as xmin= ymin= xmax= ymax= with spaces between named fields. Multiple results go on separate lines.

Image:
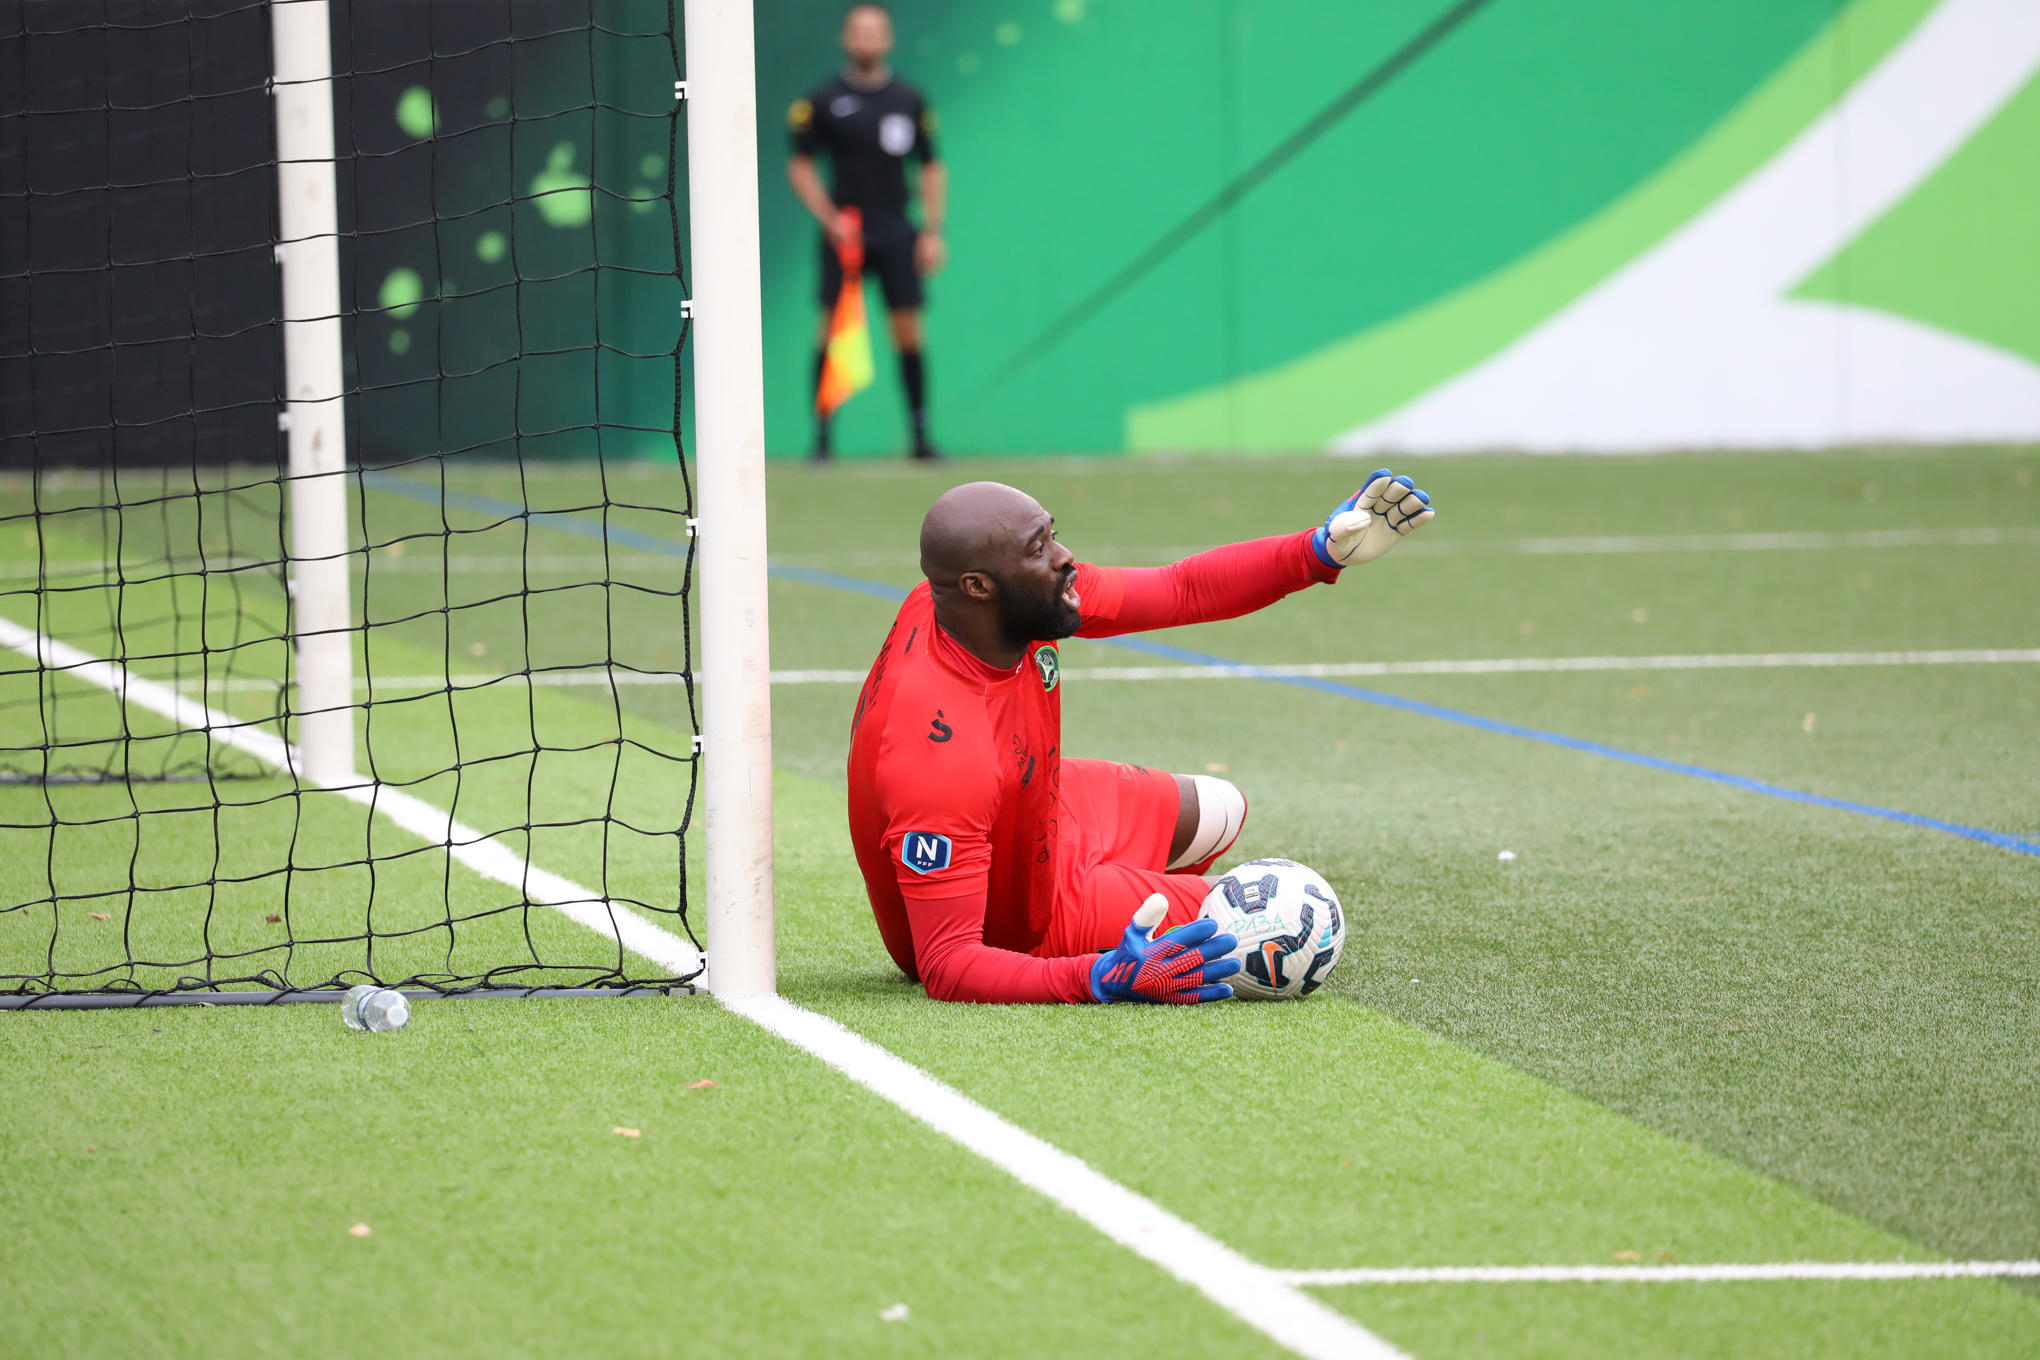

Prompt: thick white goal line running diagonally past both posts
xmin=0 ymin=618 xmax=1401 ymax=1360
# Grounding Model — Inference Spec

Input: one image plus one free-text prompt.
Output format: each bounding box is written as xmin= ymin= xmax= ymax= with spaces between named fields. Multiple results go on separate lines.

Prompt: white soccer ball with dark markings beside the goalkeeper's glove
xmin=1200 ymin=860 xmax=1346 ymax=1001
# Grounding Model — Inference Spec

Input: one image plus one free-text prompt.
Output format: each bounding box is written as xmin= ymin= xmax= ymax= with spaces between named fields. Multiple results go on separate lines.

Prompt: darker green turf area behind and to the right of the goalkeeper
xmin=758 ymin=451 xmax=2040 ymax=1280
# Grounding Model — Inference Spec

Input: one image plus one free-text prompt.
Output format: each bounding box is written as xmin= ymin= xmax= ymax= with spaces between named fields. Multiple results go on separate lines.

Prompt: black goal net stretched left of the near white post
xmin=0 ymin=0 xmax=700 ymax=1005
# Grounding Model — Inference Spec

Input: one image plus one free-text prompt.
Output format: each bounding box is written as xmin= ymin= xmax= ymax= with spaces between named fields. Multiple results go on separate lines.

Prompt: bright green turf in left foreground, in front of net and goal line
xmin=0 ymin=999 xmax=1279 ymax=1356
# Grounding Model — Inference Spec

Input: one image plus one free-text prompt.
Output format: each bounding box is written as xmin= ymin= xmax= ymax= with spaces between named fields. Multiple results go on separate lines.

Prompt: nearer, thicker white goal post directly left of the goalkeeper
xmin=675 ymin=0 xmax=777 ymax=995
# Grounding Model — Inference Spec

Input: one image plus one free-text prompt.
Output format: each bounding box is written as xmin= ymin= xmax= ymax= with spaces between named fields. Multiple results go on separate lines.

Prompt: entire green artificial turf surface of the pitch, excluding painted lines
xmin=0 ymin=451 xmax=2040 ymax=1356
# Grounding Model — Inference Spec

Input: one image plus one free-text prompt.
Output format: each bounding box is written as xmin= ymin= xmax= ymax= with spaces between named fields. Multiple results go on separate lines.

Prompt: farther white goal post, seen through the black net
xmin=269 ymin=0 xmax=355 ymax=785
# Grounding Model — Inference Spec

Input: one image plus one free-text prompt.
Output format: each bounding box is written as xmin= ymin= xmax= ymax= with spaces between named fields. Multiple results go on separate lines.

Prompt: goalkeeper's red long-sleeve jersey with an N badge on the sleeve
xmin=849 ymin=532 xmax=1338 ymax=1001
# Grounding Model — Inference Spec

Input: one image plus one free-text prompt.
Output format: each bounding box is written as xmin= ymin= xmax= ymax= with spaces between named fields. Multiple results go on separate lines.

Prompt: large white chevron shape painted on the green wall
xmin=1332 ymin=0 xmax=2040 ymax=457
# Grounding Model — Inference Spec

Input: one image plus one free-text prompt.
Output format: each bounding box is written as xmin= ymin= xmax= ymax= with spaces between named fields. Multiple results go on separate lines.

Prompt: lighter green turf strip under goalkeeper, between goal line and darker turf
xmin=762 ymin=777 xmax=2040 ymax=1354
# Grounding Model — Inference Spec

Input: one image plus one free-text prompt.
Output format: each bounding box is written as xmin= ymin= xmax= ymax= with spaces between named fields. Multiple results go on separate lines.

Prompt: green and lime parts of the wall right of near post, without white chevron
xmin=759 ymin=0 xmax=2040 ymax=453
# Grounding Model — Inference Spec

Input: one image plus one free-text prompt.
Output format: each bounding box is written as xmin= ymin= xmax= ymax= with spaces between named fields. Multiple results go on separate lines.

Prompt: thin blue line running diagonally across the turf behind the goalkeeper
xmin=363 ymin=473 xmax=2040 ymax=858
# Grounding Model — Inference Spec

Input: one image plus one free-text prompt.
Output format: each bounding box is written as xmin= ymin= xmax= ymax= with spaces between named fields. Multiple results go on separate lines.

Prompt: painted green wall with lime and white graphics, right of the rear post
xmin=337 ymin=0 xmax=2040 ymax=459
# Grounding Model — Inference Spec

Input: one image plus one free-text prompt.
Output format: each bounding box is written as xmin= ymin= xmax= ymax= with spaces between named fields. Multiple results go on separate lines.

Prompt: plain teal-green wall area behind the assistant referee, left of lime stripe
xmin=759 ymin=0 xmax=1838 ymax=453
